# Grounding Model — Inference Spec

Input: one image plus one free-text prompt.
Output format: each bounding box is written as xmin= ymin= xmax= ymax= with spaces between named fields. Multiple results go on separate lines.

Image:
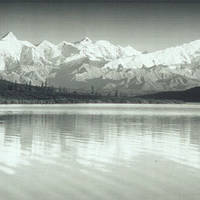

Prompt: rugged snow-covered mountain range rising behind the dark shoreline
xmin=0 ymin=32 xmax=200 ymax=94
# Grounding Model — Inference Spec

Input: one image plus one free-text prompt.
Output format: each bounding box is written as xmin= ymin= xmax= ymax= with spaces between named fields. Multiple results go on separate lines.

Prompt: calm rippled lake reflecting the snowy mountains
xmin=0 ymin=104 xmax=200 ymax=200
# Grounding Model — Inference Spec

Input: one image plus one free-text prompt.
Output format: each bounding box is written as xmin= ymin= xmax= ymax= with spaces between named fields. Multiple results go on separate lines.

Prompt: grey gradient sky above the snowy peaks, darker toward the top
xmin=0 ymin=0 xmax=200 ymax=51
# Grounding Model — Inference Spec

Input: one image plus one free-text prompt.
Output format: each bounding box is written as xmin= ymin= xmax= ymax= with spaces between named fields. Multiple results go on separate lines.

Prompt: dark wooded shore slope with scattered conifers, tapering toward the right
xmin=0 ymin=80 xmax=183 ymax=104
